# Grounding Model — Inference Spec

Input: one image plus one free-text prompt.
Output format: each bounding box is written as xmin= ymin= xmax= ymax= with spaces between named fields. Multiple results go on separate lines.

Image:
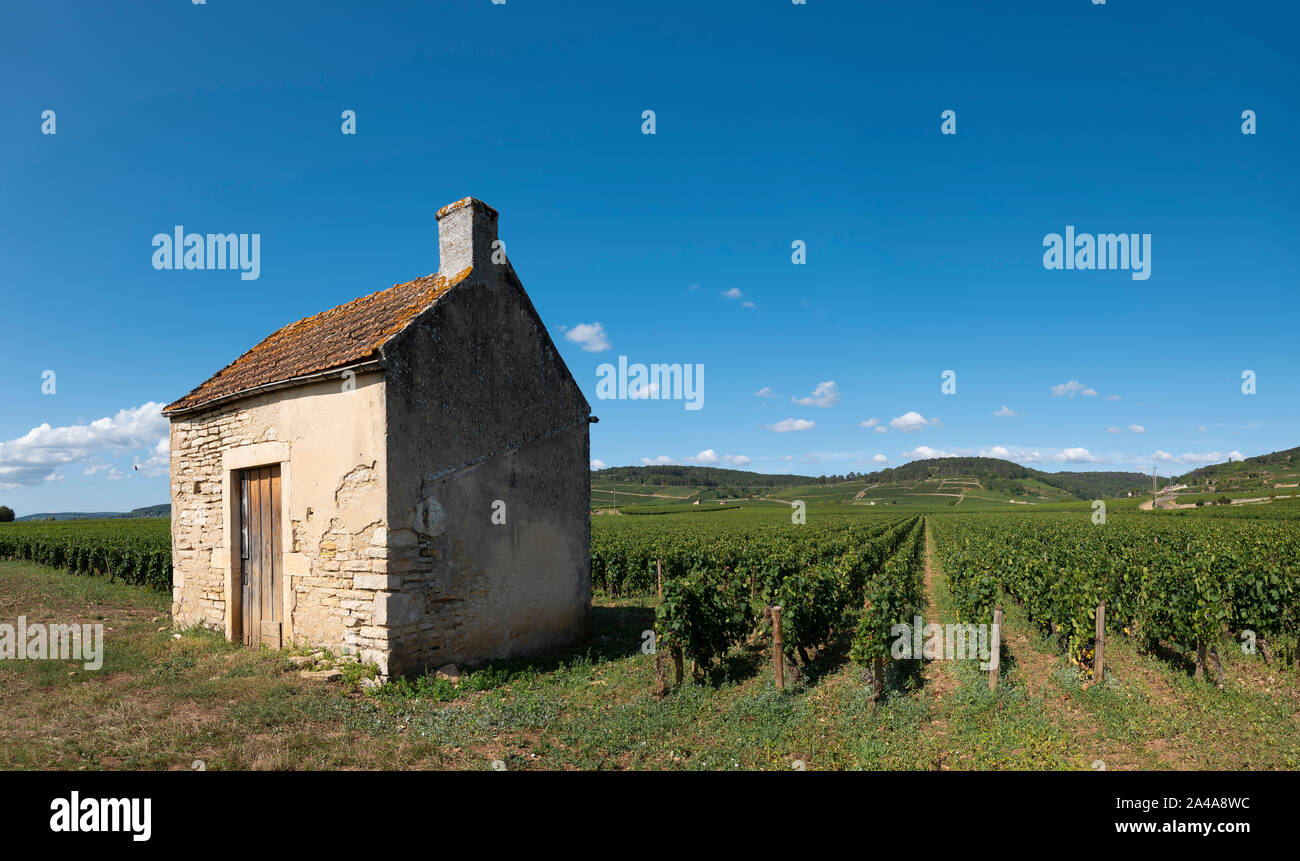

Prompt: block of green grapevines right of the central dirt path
xmin=933 ymin=512 xmax=1300 ymax=676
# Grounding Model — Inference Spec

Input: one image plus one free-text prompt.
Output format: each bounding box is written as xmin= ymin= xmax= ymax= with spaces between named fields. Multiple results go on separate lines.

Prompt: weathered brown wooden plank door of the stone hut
xmin=239 ymin=466 xmax=283 ymax=649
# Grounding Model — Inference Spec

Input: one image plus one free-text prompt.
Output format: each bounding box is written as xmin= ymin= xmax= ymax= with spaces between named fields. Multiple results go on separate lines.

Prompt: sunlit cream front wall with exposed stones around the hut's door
xmin=172 ymin=373 xmax=387 ymax=667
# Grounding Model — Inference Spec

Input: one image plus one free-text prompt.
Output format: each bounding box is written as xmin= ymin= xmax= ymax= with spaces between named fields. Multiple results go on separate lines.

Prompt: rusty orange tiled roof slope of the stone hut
xmin=163 ymin=269 xmax=469 ymax=415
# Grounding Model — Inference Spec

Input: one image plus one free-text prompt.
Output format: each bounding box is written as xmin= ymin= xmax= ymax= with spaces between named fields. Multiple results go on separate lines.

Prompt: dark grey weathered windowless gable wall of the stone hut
xmin=376 ymin=264 xmax=590 ymax=674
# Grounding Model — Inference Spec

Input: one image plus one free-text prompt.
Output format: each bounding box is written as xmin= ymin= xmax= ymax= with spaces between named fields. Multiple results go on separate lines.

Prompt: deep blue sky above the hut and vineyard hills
xmin=0 ymin=0 xmax=1300 ymax=515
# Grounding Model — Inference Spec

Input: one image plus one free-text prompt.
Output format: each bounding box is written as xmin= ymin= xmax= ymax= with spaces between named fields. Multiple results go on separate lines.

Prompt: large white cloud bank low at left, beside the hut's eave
xmin=0 ymin=401 xmax=168 ymax=490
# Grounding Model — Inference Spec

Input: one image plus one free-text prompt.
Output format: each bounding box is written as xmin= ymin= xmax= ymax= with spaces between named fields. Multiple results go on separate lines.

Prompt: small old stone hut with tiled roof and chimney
xmin=164 ymin=198 xmax=592 ymax=676
